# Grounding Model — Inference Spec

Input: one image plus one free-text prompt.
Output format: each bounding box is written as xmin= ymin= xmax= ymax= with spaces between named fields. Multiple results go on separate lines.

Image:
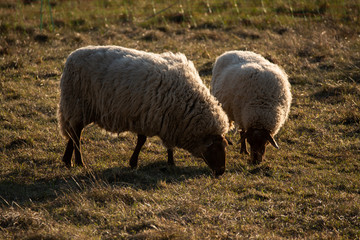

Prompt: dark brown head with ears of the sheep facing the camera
xmin=240 ymin=128 xmax=279 ymax=164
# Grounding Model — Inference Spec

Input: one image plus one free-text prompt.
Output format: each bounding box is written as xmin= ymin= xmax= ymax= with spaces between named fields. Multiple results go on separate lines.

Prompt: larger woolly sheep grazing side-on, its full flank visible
xmin=58 ymin=46 xmax=229 ymax=176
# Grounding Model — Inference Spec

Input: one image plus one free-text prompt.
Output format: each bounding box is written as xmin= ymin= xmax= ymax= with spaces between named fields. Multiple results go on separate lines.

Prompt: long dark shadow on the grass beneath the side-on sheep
xmin=0 ymin=161 xmax=212 ymax=208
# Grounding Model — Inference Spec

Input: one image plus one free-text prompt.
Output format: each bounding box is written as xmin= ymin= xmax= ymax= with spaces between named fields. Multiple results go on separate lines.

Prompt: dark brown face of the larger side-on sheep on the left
xmin=202 ymin=135 xmax=228 ymax=177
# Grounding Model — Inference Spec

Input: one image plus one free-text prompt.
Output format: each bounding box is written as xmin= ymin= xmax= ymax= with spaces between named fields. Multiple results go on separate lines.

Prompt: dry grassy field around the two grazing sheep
xmin=0 ymin=0 xmax=360 ymax=239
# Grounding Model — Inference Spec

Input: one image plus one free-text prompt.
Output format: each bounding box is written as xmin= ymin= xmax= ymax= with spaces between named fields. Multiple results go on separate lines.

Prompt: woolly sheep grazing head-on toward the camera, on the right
xmin=211 ymin=51 xmax=292 ymax=164
